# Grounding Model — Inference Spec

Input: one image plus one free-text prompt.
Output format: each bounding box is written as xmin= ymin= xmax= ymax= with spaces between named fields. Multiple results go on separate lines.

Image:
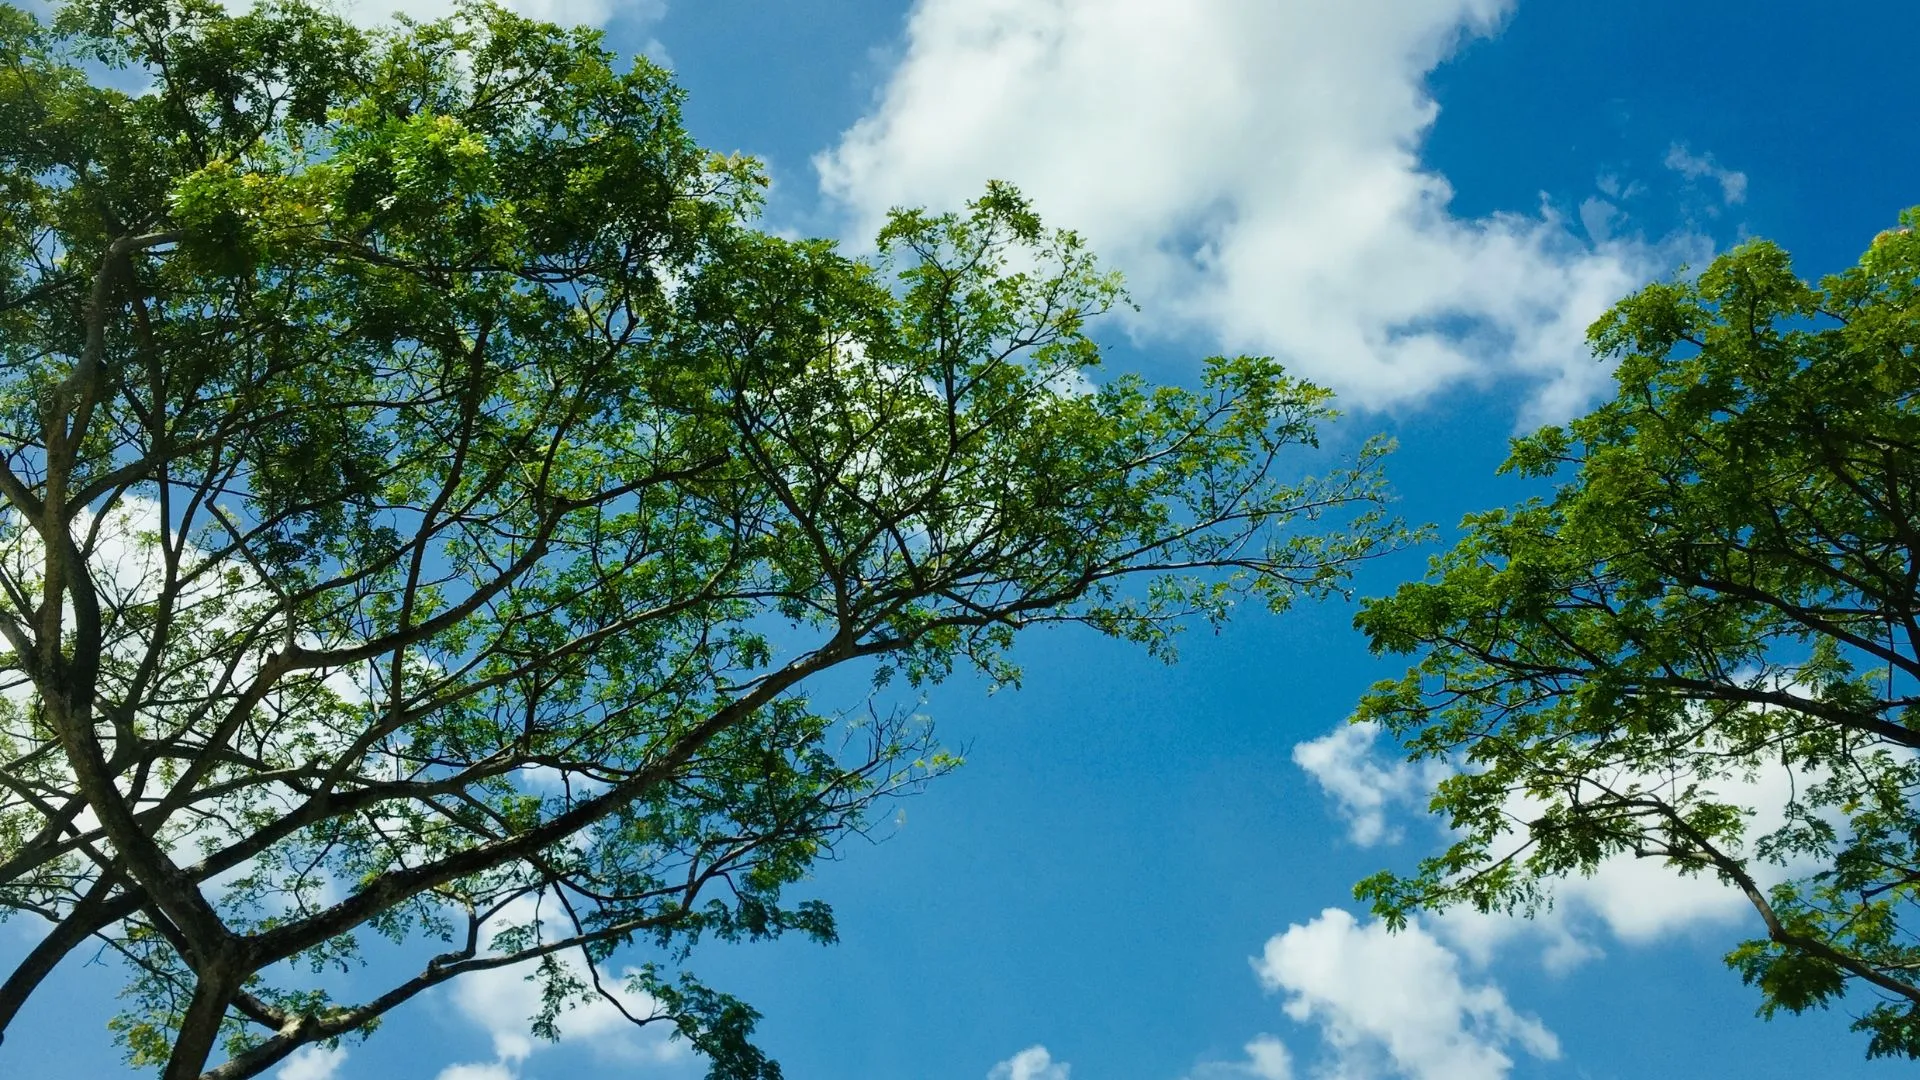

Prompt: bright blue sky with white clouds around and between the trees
xmin=0 ymin=0 xmax=1920 ymax=1080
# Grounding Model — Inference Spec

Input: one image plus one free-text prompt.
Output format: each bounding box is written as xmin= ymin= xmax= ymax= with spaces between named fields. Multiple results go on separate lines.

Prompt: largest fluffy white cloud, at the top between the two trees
xmin=816 ymin=0 xmax=1668 ymax=419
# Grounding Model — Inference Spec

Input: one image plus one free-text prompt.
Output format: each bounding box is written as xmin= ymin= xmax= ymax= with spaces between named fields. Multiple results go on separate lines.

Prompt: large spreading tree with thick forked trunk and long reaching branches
xmin=0 ymin=0 xmax=1404 ymax=1080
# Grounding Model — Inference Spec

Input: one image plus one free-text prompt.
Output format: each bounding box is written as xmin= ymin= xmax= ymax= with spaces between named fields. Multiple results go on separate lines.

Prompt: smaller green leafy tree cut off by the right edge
xmin=1356 ymin=211 xmax=1920 ymax=1057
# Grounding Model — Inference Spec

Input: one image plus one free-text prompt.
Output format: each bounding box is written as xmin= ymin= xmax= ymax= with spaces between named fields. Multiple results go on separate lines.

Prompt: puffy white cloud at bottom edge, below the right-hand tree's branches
xmin=1254 ymin=907 xmax=1559 ymax=1080
